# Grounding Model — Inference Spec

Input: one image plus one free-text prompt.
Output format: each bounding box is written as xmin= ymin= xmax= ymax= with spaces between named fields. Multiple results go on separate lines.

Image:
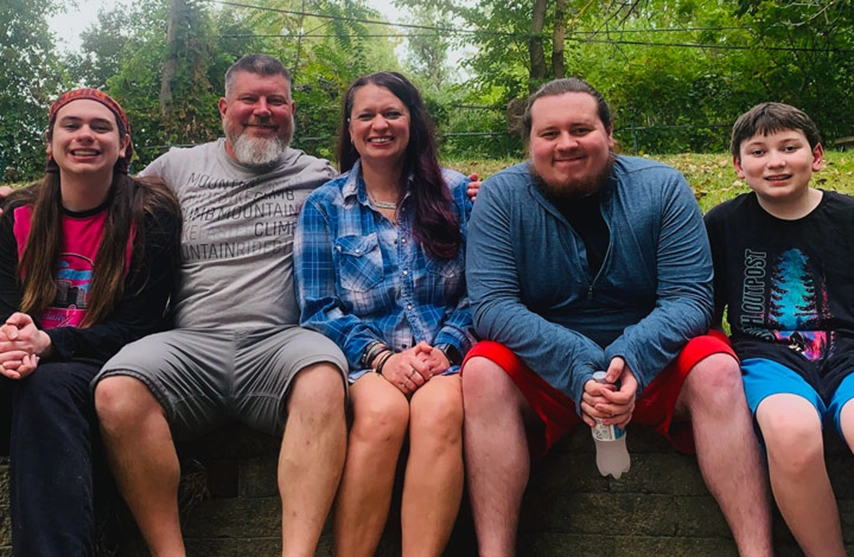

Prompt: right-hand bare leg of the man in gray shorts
xmin=279 ymin=363 xmax=347 ymax=557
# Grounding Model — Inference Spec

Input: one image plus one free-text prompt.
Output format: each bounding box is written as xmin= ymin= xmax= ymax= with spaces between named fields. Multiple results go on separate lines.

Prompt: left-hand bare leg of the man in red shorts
xmin=462 ymin=358 xmax=532 ymax=557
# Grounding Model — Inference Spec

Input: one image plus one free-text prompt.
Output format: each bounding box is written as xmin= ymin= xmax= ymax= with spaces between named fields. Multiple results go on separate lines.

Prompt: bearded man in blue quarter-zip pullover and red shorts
xmin=462 ymin=79 xmax=771 ymax=556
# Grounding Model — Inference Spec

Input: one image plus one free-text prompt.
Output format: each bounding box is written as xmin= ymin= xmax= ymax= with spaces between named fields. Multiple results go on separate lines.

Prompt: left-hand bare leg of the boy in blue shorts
xmin=756 ymin=394 xmax=845 ymax=557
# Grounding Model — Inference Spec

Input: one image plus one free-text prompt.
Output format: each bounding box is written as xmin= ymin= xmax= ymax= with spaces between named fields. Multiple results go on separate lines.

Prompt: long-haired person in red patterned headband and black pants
xmin=0 ymin=89 xmax=181 ymax=557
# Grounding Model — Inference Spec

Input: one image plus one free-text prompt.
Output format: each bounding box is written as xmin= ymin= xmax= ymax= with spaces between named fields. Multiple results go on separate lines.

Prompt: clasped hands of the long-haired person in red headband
xmin=0 ymin=313 xmax=50 ymax=379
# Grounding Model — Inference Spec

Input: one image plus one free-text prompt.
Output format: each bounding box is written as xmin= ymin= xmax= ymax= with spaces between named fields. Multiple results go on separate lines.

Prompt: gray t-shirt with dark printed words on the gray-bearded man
xmin=141 ymin=139 xmax=337 ymax=330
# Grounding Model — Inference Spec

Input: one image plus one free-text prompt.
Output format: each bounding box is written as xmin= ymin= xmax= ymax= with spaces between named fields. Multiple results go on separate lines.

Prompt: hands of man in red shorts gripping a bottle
xmin=581 ymin=357 xmax=638 ymax=428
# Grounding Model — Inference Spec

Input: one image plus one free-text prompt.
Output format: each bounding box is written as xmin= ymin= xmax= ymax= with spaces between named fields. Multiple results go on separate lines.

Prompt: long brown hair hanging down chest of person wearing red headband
xmin=6 ymin=172 xmax=181 ymax=327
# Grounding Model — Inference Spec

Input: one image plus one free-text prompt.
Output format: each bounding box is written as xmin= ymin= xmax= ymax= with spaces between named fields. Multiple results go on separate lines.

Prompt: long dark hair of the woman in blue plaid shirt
xmin=338 ymin=72 xmax=462 ymax=259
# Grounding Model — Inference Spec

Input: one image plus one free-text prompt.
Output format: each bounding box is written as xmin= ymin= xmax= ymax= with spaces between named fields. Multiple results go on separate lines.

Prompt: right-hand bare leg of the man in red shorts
xmin=676 ymin=354 xmax=773 ymax=557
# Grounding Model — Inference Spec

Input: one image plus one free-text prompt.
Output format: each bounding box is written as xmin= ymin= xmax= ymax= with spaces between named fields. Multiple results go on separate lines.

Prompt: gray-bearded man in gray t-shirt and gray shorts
xmin=95 ymin=55 xmax=347 ymax=556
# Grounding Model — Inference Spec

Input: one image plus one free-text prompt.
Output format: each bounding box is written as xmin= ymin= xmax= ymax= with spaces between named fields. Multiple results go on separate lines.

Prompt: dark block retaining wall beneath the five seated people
xmin=0 ymin=426 xmax=854 ymax=557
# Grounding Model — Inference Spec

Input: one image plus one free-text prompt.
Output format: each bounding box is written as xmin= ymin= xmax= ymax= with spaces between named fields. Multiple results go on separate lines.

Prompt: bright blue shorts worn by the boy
xmin=741 ymin=358 xmax=854 ymax=440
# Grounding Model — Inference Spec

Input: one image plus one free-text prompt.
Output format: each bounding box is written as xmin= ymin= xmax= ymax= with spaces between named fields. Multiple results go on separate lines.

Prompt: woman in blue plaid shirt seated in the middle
xmin=294 ymin=72 xmax=474 ymax=555
